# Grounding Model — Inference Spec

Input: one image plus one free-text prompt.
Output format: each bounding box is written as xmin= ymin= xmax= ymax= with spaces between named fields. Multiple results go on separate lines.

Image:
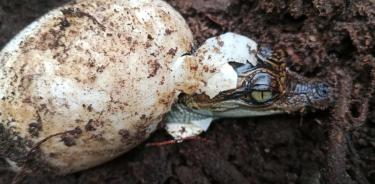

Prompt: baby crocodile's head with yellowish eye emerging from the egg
xmin=180 ymin=48 xmax=332 ymax=117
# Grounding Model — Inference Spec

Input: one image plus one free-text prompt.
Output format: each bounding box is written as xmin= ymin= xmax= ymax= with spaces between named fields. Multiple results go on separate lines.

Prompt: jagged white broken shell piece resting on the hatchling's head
xmin=196 ymin=33 xmax=258 ymax=98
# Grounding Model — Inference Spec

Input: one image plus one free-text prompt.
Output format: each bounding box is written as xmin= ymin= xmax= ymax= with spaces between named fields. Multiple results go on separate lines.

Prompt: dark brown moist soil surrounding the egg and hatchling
xmin=0 ymin=0 xmax=375 ymax=184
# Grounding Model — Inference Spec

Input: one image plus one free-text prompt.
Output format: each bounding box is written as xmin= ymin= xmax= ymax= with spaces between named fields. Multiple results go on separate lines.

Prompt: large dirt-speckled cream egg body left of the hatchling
xmin=0 ymin=0 xmax=193 ymax=174
